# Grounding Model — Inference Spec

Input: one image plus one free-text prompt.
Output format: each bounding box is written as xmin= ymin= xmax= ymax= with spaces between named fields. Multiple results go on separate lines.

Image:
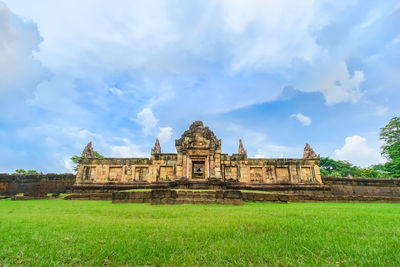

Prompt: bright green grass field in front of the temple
xmin=0 ymin=199 xmax=400 ymax=266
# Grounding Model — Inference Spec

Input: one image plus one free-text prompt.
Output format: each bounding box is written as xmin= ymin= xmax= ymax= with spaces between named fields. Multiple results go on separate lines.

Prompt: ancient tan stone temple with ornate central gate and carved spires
xmin=76 ymin=121 xmax=321 ymax=184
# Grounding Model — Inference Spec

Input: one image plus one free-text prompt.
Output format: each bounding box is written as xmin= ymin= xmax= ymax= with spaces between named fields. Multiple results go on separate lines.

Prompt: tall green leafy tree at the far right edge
xmin=379 ymin=117 xmax=400 ymax=177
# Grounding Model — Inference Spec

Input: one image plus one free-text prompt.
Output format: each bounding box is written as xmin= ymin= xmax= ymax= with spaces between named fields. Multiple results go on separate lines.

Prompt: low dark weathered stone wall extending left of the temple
xmin=0 ymin=173 xmax=75 ymax=197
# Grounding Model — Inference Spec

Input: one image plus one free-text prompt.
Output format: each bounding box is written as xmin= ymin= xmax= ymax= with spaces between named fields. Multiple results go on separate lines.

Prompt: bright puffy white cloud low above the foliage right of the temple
xmin=335 ymin=135 xmax=385 ymax=167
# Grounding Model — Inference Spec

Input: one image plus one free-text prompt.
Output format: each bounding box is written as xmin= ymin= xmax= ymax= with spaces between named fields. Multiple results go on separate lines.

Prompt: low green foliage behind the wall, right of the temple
xmin=319 ymin=157 xmax=389 ymax=178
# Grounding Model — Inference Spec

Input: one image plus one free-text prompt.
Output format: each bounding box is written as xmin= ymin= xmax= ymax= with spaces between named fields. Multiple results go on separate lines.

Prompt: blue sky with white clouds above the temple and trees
xmin=0 ymin=0 xmax=400 ymax=173
